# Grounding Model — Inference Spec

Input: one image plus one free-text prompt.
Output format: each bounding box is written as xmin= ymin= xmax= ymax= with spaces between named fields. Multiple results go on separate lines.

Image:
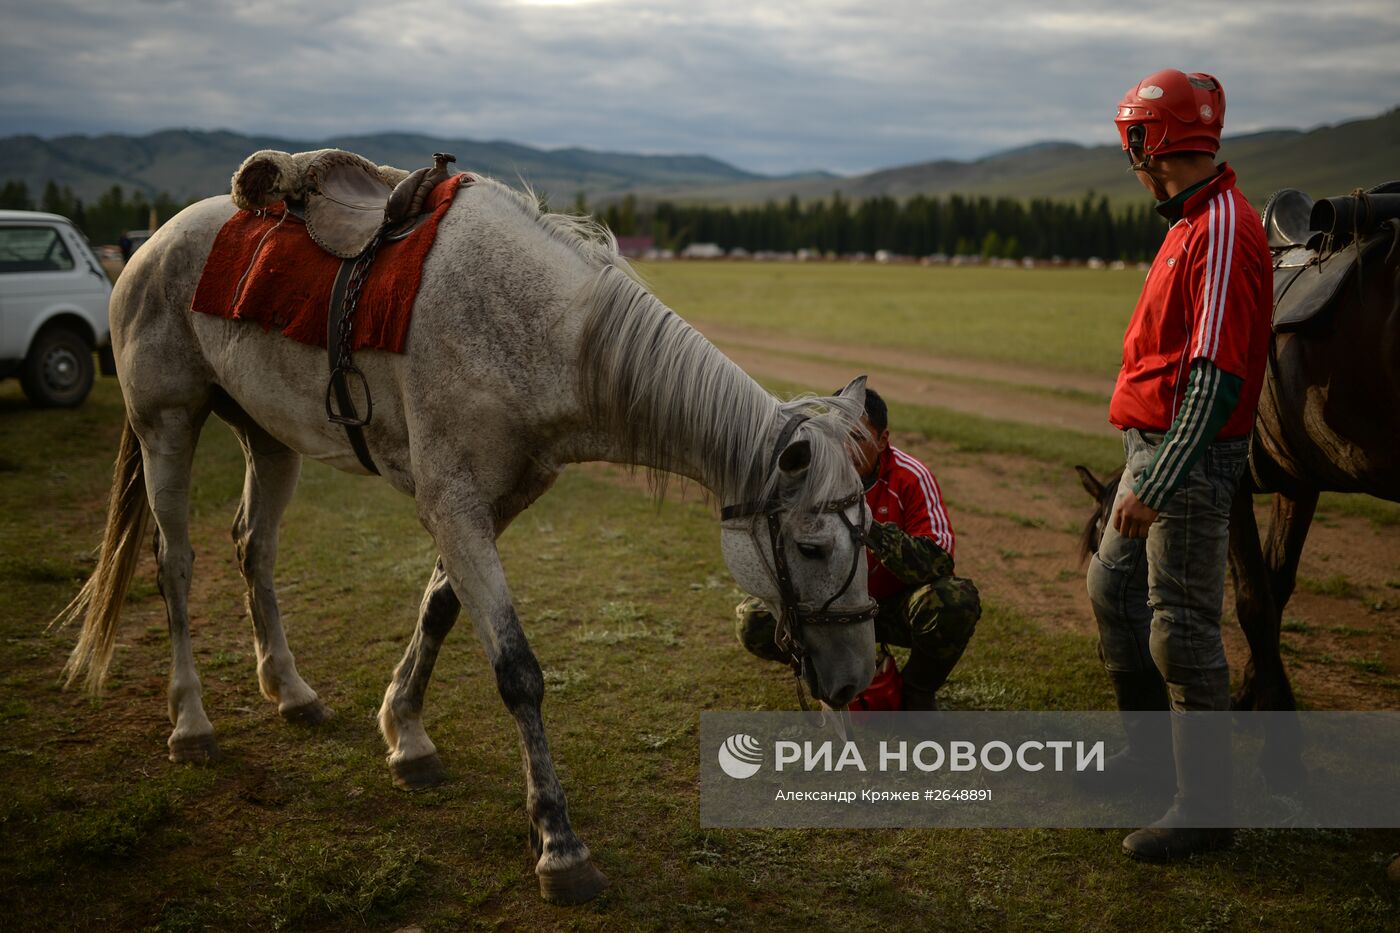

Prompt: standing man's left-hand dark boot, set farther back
xmin=1074 ymin=668 xmax=1176 ymax=804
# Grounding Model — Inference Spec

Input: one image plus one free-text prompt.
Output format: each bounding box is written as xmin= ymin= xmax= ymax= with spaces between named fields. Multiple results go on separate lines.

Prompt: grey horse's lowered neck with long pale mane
xmin=459 ymin=184 xmax=778 ymax=497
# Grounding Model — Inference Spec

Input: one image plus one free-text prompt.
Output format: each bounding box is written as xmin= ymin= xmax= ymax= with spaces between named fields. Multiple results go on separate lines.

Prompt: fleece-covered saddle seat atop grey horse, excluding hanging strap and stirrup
xmin=232 ymin=148 xmax=456 ymax=259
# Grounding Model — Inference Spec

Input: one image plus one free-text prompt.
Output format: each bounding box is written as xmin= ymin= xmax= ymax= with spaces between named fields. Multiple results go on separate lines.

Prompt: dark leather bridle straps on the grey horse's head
xmin=720 ymin=415 xmax=879 ymax=689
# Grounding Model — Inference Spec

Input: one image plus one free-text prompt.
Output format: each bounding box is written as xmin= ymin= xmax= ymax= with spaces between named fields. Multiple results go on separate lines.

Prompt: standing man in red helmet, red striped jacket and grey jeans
xmin=1088 ymin=70 xmax=1273 ymax=860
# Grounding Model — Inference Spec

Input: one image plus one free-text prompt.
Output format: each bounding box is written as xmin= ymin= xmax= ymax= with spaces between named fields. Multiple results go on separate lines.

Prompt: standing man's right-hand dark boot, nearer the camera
xmin=1123 ymin=713 xmax=1235 ymax=862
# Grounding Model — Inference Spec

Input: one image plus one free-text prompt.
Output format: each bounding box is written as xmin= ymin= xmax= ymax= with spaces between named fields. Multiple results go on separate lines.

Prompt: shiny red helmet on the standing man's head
xmin=1113 ymin=69 xmax=1225 ymax=164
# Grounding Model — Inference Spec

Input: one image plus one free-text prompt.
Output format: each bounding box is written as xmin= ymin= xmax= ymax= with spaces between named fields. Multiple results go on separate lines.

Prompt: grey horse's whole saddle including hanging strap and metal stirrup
xmin=231 ymin=148 xmax=467 ymax=474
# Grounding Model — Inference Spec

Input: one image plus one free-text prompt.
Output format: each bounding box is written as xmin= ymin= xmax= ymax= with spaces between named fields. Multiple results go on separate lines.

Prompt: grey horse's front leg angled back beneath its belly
xmin=379 ymin=560 xmax=462 ymax=790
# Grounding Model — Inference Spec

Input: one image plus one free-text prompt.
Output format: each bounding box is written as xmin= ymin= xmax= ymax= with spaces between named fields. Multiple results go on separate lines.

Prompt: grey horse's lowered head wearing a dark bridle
xmin=721 ymin=377 xmax=876 ymax=707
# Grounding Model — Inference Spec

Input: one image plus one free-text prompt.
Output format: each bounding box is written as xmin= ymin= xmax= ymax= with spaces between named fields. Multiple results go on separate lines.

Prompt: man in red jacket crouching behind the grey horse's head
xmin=736 ymin=387 xmax=981 ymax=710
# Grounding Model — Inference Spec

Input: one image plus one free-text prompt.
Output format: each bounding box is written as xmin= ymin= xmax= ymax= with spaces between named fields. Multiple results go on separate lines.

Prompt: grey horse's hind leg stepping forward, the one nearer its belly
xmin=232 ymin=420 xmax=332 ymax=726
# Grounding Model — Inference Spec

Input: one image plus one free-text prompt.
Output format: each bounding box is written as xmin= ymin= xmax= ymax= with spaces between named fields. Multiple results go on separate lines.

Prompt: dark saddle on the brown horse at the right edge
xmin=1264 ymin=182 xmax=1400 ymax=333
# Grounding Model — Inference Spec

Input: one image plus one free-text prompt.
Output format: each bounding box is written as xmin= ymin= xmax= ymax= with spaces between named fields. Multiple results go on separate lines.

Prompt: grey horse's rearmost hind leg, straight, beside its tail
xmin=130 ymin=408 xmax=217 ymax=762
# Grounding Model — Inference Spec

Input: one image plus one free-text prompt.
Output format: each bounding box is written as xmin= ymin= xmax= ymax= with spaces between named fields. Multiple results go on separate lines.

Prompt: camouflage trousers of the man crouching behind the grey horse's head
xmin=735 ymin=577 xmax=981 ymax=693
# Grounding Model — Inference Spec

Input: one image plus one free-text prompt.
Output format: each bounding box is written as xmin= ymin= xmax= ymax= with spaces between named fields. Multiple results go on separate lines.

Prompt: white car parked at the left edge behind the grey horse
xmin=0 ymin=210 xmax=115 ymax=408
